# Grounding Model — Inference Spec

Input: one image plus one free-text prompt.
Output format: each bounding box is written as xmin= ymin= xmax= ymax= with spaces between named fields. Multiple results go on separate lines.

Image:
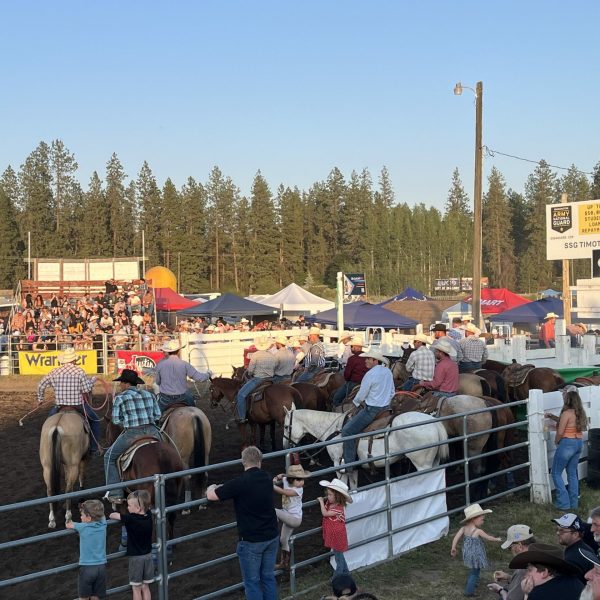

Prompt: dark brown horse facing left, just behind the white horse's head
xmin=210 ymin=377 xmax=302 ymax=451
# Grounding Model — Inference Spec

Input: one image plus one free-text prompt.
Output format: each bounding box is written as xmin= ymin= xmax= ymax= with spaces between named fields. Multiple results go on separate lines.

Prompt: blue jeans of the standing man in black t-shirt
xmin=237 ymin=536 xmax=279 ymax=600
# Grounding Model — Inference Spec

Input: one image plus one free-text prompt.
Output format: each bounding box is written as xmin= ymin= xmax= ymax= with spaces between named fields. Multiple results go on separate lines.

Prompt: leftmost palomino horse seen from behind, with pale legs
xmin=40 ymin=410 xmax=90 ymax=529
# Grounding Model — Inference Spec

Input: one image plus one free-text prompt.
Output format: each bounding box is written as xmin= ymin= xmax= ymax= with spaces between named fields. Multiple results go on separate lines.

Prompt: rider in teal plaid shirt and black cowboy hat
xmin=104 ymin=369 xmax=160 ymax=502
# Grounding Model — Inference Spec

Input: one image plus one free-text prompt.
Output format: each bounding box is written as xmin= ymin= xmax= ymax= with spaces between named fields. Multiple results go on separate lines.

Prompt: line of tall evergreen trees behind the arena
xmin=0 ymin=140 xmax=600 ymax=296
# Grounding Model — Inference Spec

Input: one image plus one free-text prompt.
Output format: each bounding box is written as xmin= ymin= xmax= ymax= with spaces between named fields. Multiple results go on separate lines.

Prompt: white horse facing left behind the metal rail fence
xmin=283 ymin=409 xmax=448 ymax=490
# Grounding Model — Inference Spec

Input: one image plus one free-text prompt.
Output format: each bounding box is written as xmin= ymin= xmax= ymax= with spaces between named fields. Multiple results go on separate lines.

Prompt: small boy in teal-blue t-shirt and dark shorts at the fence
xmin=66 ymin=500 xmax=106 ymax=600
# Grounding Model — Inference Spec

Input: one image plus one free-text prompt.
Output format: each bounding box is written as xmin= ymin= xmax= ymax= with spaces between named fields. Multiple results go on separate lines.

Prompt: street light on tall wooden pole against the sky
xmin=454 ymin=81 xmax=483 ymax=327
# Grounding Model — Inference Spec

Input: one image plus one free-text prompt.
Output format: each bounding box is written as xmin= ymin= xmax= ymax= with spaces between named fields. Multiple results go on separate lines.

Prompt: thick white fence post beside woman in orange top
xmin=527 ymin=390 xmax=552 ymax=504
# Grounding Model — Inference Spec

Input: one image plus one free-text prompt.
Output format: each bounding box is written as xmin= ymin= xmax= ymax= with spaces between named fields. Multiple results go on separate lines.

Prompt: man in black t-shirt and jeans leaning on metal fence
xmin=206 ymin=446 xmax=279 ymax=600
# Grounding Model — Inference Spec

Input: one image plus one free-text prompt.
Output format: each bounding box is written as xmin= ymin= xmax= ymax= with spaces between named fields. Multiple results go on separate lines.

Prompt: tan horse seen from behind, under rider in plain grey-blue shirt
xmin=161 ymin=406 xmax=212 ymax=512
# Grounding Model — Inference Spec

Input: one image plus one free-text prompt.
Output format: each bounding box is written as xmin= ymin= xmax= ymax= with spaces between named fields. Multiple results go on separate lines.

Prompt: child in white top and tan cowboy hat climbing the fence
xmin=273 ymin=465 xmax=310 ymax=569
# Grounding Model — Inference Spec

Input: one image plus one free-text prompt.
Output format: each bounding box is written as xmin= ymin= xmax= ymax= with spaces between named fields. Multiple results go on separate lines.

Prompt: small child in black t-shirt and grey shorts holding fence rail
xmin=109 ymin=490 xmax=154 ymax=600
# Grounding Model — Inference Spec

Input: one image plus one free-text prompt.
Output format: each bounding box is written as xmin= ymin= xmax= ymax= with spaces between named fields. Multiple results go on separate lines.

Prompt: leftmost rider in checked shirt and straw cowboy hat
xmin=37 ymin=348 xmax=110 ymax=456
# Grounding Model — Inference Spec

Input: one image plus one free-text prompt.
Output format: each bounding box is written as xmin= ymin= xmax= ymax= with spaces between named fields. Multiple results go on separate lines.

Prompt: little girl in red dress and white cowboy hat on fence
xmin=319 ymin=479 xmax=352 ymax=577
